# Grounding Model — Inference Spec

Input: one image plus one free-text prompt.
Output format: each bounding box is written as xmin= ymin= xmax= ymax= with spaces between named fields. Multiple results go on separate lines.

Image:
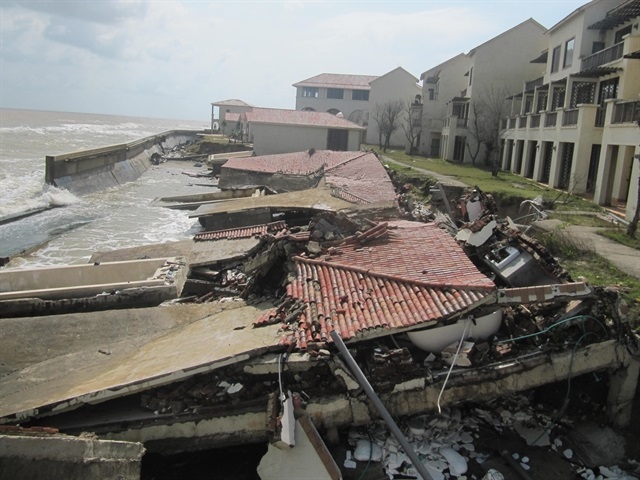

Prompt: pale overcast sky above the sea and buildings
xmin=0 ymin=0 xmax=587 ymax=121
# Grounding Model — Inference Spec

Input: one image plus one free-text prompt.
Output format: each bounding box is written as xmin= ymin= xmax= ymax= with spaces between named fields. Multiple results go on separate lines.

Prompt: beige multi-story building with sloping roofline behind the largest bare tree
xmin=420 ymin=18 xmax=546 ymax=162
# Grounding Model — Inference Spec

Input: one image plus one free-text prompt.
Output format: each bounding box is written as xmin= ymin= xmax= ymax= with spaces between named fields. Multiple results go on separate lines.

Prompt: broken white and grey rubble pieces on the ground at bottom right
xmin=343 ymin=395 xmax=638 ymax=480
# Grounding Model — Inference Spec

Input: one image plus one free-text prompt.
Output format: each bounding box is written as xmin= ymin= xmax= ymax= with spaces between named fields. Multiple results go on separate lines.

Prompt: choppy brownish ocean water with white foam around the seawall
xmin=0 ymin=108 xmax=212 ymax=267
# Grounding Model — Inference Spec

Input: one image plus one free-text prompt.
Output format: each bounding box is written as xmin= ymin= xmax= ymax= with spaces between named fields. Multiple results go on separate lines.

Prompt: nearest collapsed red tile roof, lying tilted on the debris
xmin=256 ymin=221 xmax=495 ymax=349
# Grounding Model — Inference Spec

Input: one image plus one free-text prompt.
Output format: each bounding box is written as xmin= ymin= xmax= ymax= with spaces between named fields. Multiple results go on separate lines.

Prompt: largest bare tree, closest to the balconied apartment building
xmin=467 ymin=86 xmax=508 ymax=177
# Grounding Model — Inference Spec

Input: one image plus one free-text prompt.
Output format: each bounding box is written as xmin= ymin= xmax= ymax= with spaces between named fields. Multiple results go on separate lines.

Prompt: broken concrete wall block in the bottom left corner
xmin=0 ymin=435 xmax=144 ymax=480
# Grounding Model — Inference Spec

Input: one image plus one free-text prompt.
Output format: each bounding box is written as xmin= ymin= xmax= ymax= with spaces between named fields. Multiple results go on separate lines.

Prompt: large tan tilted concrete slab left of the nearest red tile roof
xmin=0 ymin=301 xmax=279 ymax=422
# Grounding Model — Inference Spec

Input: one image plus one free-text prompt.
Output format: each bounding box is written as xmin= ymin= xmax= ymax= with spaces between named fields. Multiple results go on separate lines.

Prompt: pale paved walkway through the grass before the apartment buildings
xmin=382 ymin=155 xmax=640 ymax=278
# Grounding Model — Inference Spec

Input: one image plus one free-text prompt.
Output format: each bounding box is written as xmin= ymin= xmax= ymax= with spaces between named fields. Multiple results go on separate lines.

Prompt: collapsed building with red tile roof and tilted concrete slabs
xmin=0 ymin=148 xmax=640 ymax=478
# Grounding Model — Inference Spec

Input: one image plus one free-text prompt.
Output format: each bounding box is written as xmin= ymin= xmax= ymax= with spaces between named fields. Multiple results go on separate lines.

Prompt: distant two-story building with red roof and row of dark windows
xmin=293 ymin=73 xmax=378 ymax=126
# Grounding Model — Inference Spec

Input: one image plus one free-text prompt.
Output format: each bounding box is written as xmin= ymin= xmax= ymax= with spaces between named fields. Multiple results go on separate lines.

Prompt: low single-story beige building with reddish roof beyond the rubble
xmin=242 ymin=108 xmax=365 ymax=155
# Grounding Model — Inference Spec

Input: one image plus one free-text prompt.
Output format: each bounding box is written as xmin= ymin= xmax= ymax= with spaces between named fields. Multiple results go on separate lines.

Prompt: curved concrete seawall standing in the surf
xmin=45 ymin=130 xmax=199 ymax=195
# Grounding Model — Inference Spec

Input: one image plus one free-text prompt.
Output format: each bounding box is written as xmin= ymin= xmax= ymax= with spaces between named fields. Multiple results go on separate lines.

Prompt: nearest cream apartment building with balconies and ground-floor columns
xmin=501 ymin=0 xmax=640 ymax=219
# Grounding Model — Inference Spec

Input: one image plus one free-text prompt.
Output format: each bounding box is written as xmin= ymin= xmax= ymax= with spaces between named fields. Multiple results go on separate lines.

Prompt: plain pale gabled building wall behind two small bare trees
xmin=366 ymin=67 xmax=422 ymax=146
